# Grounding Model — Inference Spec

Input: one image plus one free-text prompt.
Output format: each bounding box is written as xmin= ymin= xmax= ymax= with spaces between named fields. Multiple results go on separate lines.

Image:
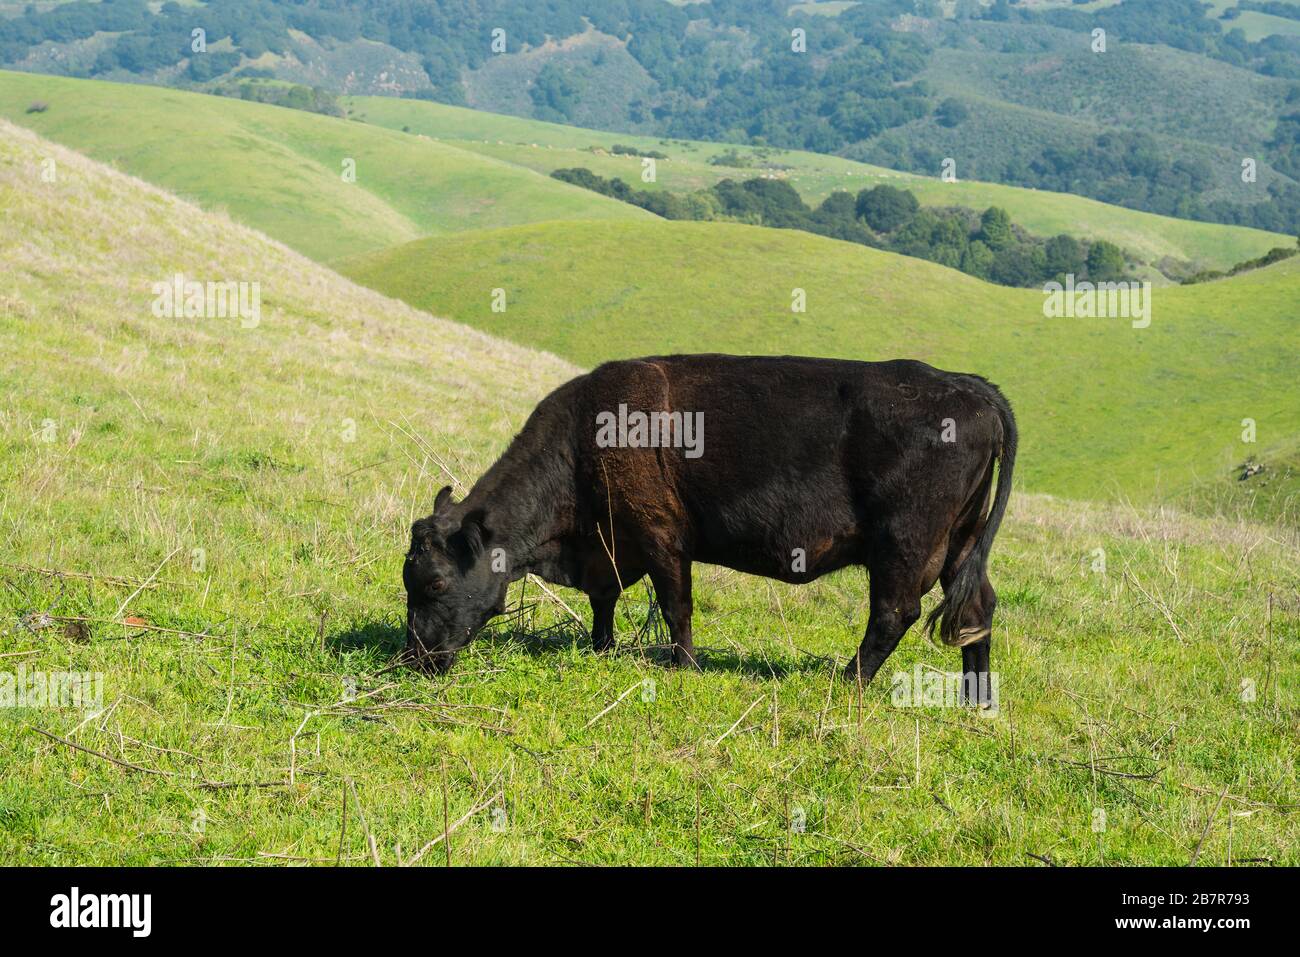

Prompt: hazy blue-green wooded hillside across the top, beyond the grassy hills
xmin=0 ymin=0 xmax=1300 ymax=233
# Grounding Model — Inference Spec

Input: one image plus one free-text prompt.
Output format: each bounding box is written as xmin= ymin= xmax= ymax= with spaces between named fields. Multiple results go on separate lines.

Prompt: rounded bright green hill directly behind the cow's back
xmin=343 ymin=222 xmax=1300 ymax=515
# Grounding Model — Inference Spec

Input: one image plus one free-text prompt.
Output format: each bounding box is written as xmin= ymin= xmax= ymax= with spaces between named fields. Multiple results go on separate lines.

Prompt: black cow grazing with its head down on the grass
xmin=402 ymin=355 xmax=1017 ymax=688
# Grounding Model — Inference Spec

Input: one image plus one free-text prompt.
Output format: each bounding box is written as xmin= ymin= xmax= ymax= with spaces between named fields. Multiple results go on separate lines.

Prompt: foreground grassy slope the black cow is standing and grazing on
xmin=0 ymin=122 xmax=1300 ymax=865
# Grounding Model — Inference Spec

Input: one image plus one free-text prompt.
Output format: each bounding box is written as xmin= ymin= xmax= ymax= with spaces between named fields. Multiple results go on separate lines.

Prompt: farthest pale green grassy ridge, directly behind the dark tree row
xmin=346 ymin=96 xmax=1295 ymax=268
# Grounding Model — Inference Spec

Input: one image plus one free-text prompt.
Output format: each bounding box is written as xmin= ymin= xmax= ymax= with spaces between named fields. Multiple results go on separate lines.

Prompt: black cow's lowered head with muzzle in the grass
xmin=402 ymin=488 xmax=510 ymax=674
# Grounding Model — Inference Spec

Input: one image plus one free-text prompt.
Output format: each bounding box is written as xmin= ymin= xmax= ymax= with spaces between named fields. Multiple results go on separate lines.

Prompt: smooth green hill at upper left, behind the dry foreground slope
xmin=0 ymin=72 xmax=649 ymax=260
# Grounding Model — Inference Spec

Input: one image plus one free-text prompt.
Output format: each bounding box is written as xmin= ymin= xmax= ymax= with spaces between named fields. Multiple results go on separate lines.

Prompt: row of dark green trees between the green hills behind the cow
xmin=551 ymin=168 xmax=1128 ymax=286
